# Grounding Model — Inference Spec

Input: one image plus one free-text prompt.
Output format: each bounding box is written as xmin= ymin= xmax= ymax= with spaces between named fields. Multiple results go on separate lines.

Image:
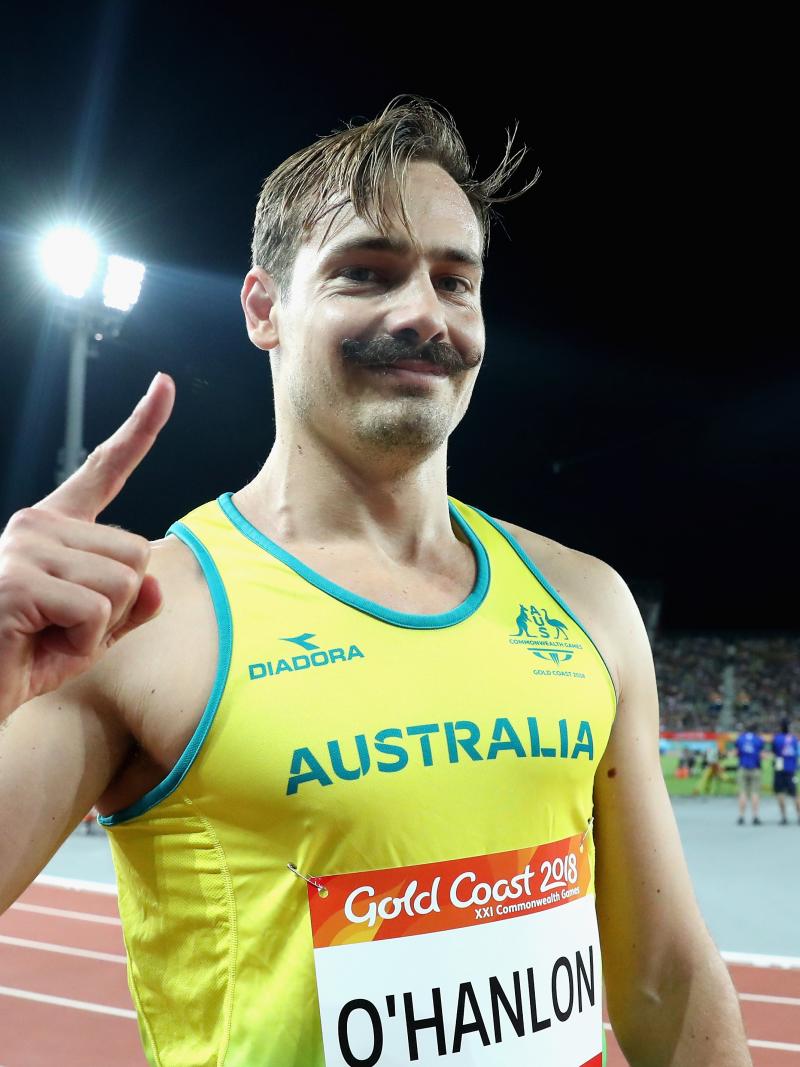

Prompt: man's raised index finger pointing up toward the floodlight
xmin=36 ymin=371 xmax=175 ymax=522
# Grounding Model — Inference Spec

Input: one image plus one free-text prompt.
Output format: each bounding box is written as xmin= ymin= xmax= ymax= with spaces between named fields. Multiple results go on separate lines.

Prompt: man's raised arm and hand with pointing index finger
xmin=0 ymin=376 xmax=174 ymax=910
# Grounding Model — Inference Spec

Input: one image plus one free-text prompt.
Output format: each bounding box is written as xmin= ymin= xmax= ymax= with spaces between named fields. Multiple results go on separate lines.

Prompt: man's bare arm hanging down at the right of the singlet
xmin=594 ymin=563 xmax=752 ymax=1067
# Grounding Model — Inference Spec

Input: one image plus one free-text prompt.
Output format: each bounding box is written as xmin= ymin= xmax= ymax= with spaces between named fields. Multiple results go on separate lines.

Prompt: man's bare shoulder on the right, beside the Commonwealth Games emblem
xmin=497 ymin=520 xmax=650 ymax=695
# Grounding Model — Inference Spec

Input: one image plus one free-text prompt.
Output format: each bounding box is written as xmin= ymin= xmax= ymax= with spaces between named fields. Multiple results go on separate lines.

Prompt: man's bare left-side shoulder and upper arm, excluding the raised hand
xmin=0 ymin=529 xmax=210 ymax=912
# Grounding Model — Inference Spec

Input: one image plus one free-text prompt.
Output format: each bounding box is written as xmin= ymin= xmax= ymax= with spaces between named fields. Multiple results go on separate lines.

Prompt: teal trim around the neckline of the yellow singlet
xmin=217 ymin=493 xmax=491 ymax=630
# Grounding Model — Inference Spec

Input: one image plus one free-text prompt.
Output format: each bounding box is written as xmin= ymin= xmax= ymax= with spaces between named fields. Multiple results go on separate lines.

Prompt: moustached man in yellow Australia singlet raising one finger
xmin=0 ymin=98 xmax=750 ymax=1067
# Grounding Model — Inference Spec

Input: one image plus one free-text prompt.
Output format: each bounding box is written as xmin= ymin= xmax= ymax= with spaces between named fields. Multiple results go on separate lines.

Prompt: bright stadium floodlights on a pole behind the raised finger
xmin=41 ymin=226 xmax=145 ymax=484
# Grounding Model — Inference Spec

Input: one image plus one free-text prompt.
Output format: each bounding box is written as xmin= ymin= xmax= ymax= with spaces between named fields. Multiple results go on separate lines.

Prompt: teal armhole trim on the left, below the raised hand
xmin=97 ymin=523 xmax=234 ymax=826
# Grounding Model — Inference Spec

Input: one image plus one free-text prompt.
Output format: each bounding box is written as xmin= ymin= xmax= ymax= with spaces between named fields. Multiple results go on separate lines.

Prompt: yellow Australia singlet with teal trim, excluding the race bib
xmin=99 ymin=494 xmax=615 ymax=1067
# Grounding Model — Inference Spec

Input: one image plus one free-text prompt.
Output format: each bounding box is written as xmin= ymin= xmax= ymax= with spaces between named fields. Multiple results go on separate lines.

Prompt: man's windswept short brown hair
xmin=252 ymin=96 xmax=540 ymax=291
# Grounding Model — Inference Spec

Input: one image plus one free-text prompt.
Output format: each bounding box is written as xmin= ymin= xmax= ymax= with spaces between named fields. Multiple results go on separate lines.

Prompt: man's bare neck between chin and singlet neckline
xmin=234 ymin=429 xmax=457 ymax=563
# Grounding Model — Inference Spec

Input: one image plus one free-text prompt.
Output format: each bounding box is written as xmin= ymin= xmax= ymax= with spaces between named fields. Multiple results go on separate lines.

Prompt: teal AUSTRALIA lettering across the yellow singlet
xmin=286 ymin=715 xmax=594 ymax=796
